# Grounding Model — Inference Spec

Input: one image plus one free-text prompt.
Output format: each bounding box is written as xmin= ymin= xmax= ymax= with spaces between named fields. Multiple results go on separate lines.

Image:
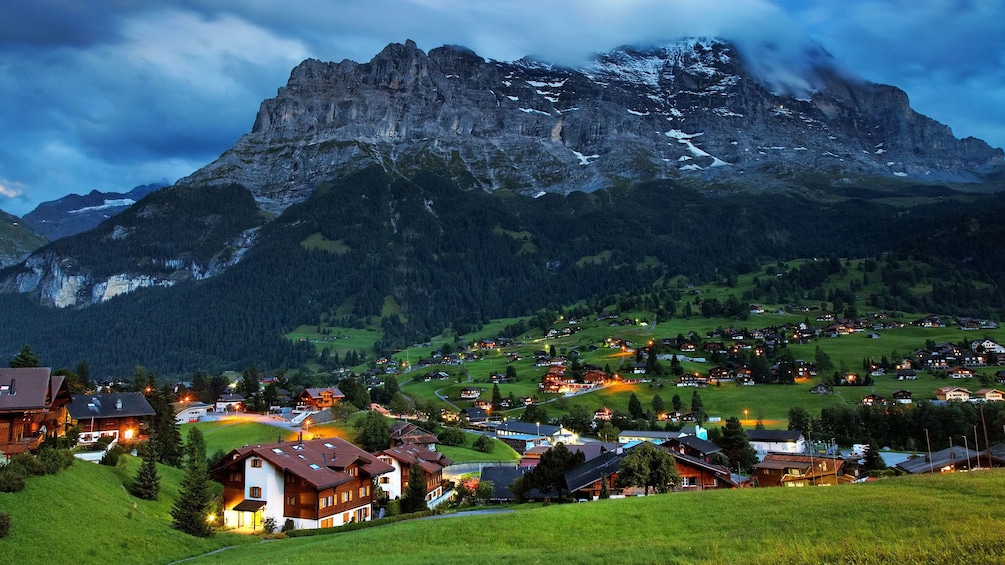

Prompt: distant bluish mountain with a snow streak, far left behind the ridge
xmin=22 ymin=183 xmax=168 ymax=241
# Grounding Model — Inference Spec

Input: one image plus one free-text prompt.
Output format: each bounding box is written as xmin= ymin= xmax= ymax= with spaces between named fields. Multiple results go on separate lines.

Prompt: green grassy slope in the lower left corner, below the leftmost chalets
xmin=0 ymin=457 xmax=254 ymax=565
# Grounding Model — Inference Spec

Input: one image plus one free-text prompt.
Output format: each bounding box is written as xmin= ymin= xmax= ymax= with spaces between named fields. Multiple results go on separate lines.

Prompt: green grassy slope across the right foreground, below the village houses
xmin=192 ymin=470 xmax=1005 ymax=564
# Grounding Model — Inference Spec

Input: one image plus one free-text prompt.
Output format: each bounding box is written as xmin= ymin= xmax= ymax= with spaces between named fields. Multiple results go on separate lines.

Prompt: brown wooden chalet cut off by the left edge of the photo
xmin=0 ymin=367 xmax=72 ymax=457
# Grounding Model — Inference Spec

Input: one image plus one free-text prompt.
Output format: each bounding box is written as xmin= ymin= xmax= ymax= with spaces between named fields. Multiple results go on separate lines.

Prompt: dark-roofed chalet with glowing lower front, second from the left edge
xmin=66 ymin=392 xmax=154 ymax=444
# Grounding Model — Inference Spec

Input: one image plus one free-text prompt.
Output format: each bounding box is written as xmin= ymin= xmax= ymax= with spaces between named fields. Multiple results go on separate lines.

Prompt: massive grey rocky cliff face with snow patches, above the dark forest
xmin=180 ymin=39 xmax=1005 ymax=211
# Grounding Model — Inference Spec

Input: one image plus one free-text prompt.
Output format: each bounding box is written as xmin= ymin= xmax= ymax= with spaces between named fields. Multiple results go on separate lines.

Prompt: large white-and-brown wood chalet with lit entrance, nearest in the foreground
xmin=211 ymin=437 xmax=394 ymax=529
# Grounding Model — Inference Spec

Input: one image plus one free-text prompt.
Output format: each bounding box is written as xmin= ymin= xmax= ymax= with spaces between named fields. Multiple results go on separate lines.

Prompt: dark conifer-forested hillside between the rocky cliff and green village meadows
xmin=0 ymin=169 xmax=1005 ymax=375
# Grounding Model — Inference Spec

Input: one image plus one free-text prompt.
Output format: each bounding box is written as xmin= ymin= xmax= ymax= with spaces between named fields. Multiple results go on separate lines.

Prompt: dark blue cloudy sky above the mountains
xmin=0 ymin=0 xmax=1005 ymax=215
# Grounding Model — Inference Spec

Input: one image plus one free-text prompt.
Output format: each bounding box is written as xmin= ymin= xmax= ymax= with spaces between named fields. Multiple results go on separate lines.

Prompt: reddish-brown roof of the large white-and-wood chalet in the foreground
xmin=217 ymin=437 xmax=394 ymax=490
